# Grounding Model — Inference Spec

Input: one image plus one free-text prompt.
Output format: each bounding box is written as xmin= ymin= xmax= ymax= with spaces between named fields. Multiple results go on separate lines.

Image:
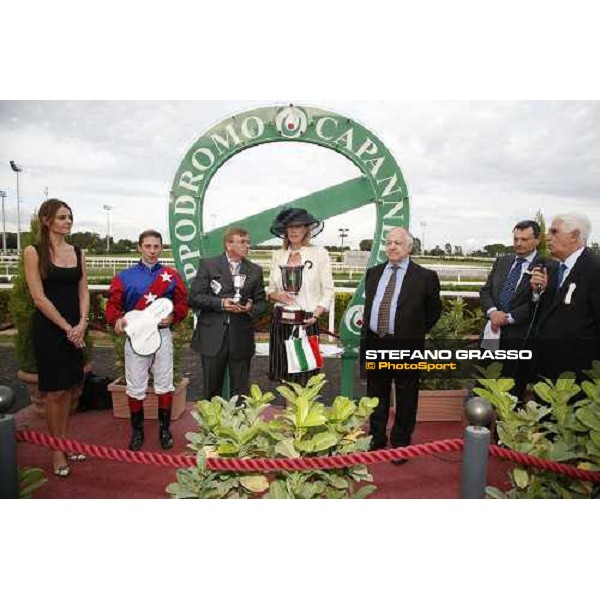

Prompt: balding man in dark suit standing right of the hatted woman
xmin=361 ymin=227 xmax=442 ymax=464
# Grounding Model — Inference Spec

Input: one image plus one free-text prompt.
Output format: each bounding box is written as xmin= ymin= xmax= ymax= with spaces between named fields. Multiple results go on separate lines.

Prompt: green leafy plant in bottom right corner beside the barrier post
xmin=474 ymin=361 xmax=600 ymax=498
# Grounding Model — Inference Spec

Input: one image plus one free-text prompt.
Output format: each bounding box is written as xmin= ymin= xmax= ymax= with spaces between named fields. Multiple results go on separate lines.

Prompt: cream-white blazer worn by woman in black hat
xmin=267 ymin=246 xmax=334 ymax=312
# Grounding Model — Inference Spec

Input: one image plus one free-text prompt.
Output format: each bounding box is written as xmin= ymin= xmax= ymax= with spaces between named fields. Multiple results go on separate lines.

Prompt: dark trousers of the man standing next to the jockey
xmin=202 ymin=327 xmax=252 ymax=400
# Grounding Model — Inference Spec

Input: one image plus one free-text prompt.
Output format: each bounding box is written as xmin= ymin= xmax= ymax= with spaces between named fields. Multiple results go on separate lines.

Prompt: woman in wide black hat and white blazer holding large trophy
xmin=267 ymin=208 xmax=334 ymax=385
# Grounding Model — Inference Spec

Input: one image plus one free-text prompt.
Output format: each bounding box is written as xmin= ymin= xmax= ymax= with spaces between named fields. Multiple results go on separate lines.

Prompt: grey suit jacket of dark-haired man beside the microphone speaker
xmin=479 ymin=254 xmax=557 ymax=340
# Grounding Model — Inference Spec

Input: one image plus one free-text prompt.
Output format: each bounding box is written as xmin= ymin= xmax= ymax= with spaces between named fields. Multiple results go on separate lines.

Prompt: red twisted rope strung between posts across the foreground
xmin=16 ymin=429 xmax=600 ymax=483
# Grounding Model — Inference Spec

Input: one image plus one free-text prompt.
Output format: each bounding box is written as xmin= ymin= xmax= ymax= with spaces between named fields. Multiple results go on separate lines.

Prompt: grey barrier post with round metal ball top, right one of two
xmin=460 ymin=397 xmax=494 ymax=500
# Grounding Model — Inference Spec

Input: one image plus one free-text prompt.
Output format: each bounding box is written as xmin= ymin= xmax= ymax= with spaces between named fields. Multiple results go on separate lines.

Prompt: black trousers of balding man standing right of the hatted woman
xmin=367 ymin=375 xmax=419 ymax=450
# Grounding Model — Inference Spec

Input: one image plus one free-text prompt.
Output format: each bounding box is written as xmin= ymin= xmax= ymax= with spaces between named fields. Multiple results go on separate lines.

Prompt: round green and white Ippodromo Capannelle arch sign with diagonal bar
xmin=169 ymin=105 xmax=409 ymax=366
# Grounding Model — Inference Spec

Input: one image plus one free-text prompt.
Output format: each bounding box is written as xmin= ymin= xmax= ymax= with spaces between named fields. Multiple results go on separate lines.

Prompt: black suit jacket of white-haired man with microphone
xmin=537 ymin=248 xmax=600 ymax=379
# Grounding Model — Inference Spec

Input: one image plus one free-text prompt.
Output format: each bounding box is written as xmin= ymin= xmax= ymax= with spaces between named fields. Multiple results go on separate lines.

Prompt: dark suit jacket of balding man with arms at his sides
xmin=361 ymin=261 xmax=442 ymax=341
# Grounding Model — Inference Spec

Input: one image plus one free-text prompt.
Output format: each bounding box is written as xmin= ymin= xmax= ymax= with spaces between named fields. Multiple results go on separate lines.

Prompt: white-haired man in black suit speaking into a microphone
xmin=532 ymin=213 xmax=600 ymax=381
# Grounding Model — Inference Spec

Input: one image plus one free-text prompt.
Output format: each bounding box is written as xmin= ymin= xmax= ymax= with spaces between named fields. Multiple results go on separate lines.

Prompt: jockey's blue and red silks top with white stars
xmin=106 ymin=261 xmax=188 ymax=327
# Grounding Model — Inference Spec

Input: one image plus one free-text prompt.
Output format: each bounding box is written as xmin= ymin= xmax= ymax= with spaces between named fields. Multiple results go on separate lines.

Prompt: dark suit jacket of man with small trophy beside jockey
xmin=189 ymin=253 xmax=266 ymax=359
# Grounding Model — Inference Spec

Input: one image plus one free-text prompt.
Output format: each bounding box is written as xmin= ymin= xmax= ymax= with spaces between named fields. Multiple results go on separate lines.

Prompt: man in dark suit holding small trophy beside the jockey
xmin=190 ymin=227 xmax=266 ymax=406
